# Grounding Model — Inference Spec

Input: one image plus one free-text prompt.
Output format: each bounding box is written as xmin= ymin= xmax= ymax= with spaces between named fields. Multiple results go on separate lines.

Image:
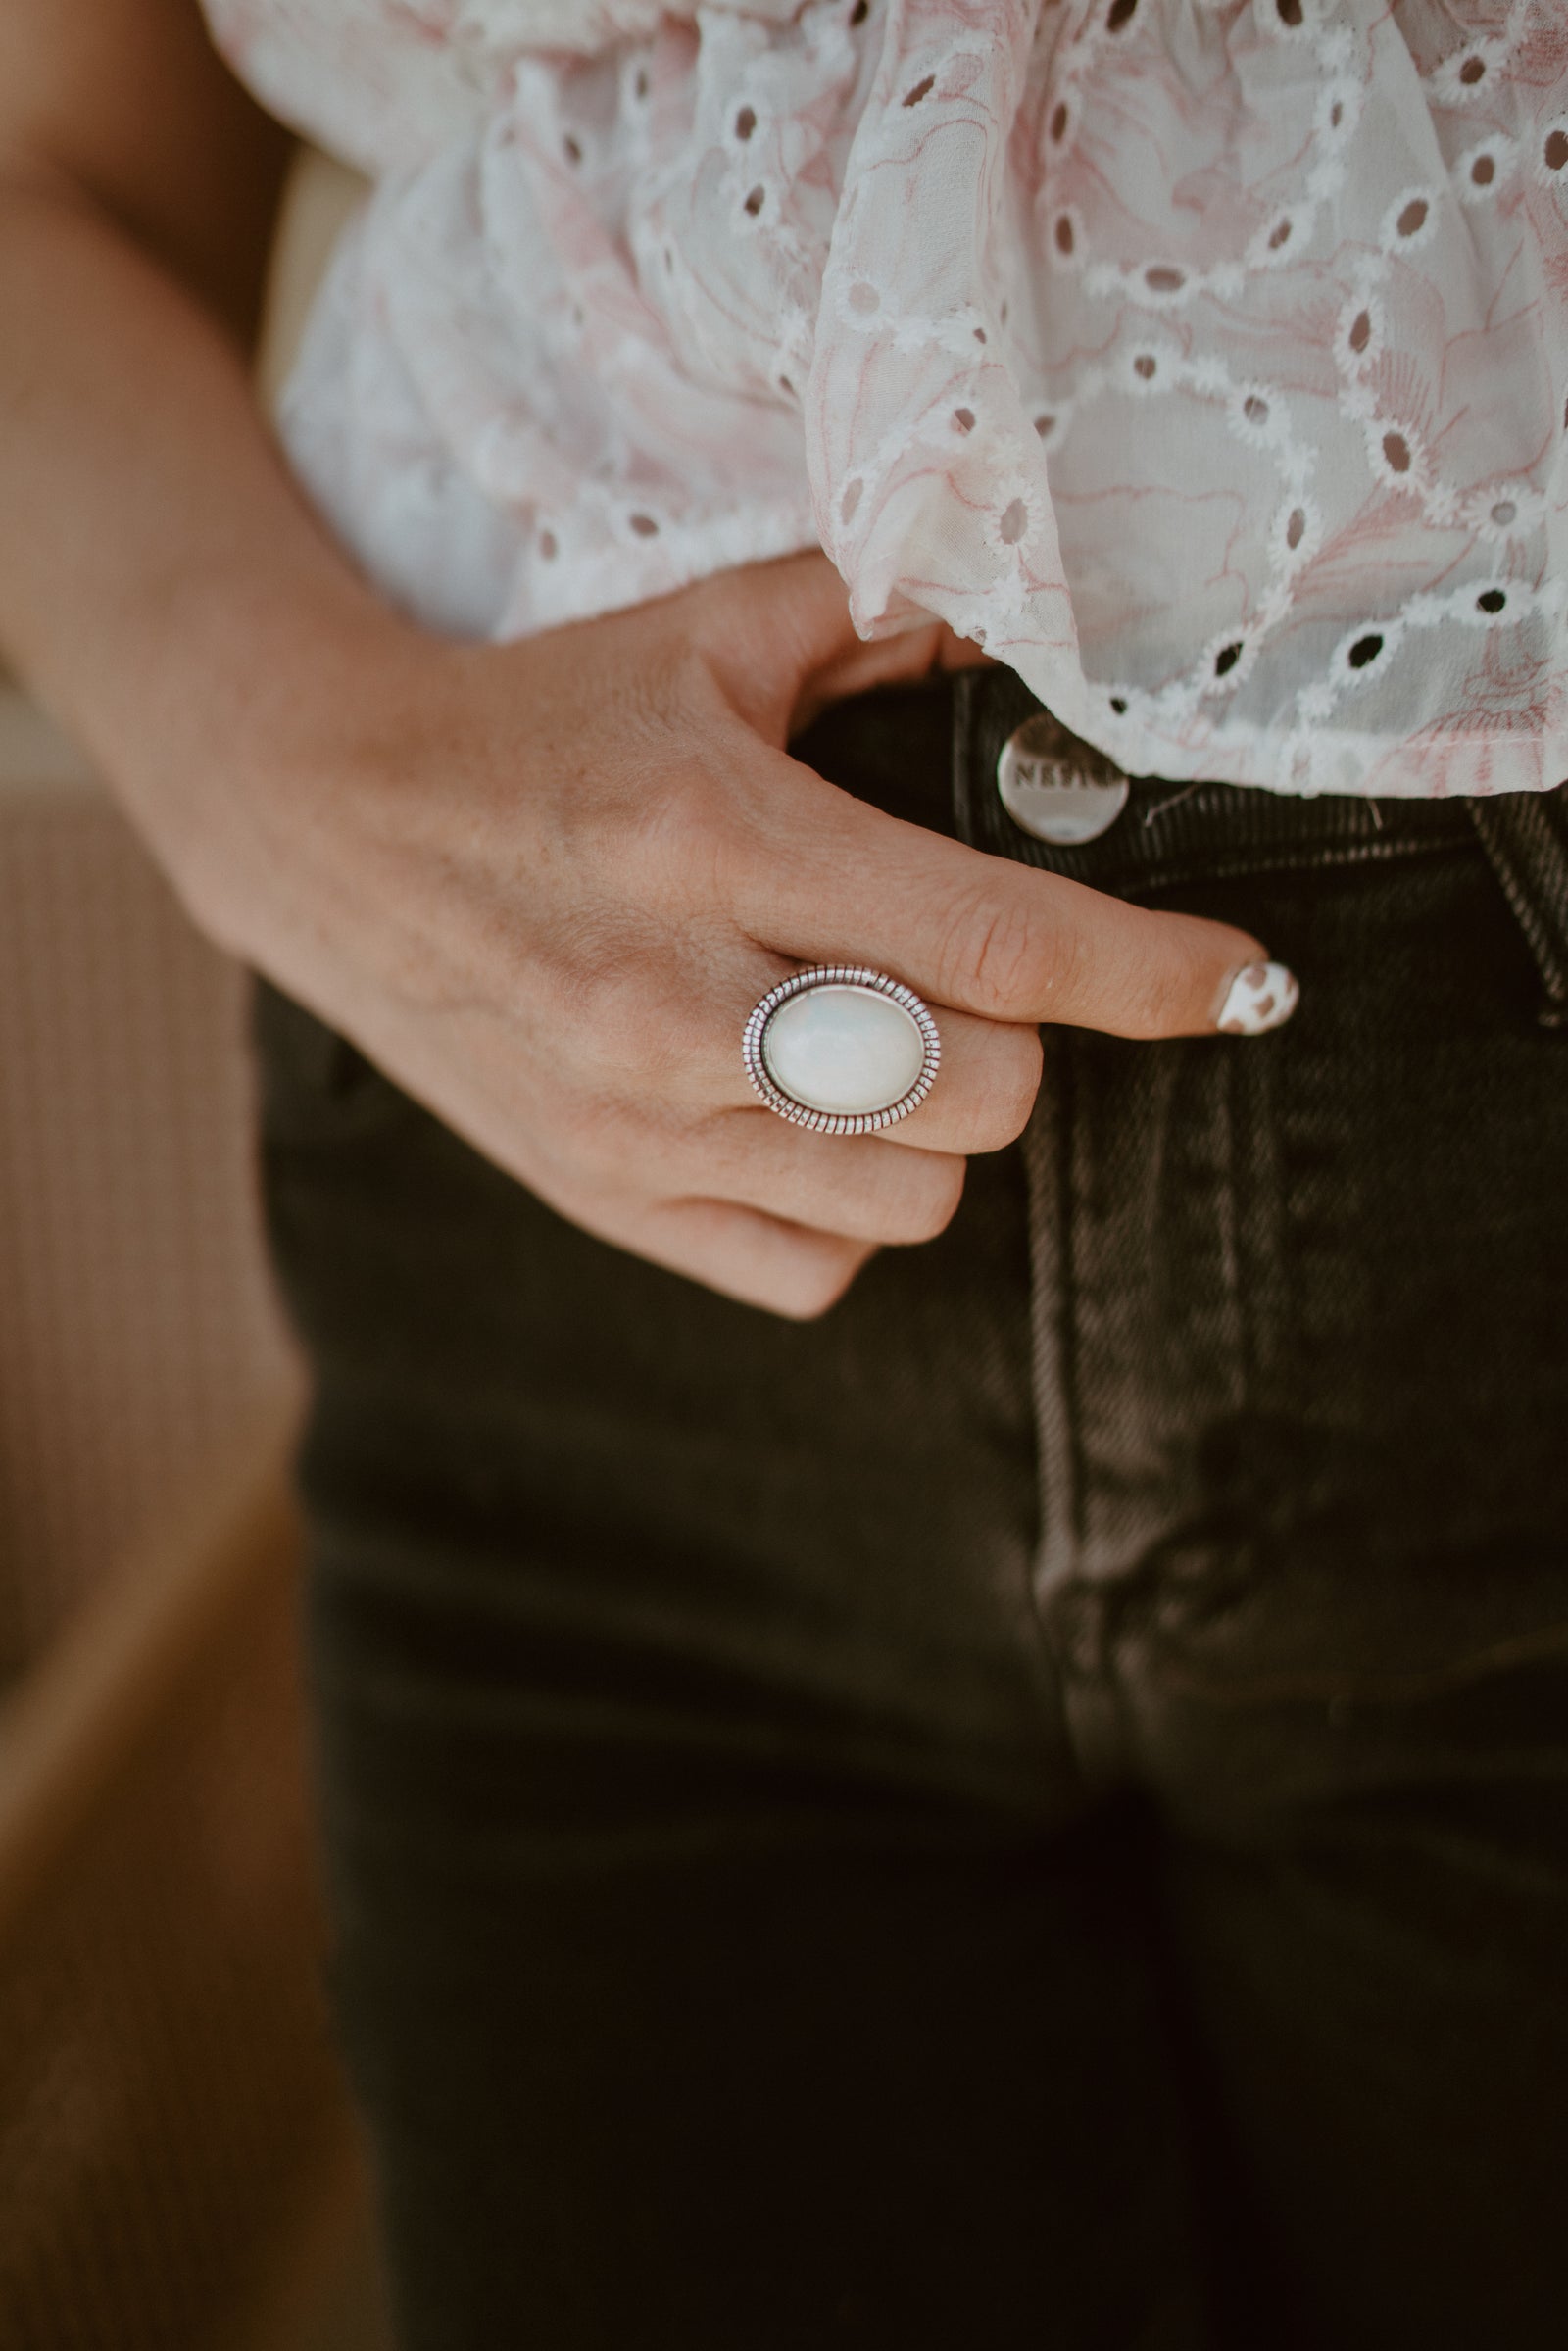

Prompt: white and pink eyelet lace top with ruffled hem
xmin=207 ymin=0 xmax=1568 ymax=795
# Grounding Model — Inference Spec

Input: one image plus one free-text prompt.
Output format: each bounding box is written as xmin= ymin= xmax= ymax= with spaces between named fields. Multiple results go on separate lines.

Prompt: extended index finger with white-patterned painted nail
xmin=736 ymin=759 xmax=1296 ymax=1037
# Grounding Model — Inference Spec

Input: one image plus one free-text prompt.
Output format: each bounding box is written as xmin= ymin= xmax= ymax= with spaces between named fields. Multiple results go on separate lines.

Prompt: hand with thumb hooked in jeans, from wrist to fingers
xmin=202 ymin=558 xmax=1288 ymax=1316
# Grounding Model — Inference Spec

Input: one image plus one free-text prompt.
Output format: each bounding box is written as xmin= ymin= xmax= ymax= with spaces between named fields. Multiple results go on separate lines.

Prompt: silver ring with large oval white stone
xmin=741 ymin=964 xmax=943 ymax=1136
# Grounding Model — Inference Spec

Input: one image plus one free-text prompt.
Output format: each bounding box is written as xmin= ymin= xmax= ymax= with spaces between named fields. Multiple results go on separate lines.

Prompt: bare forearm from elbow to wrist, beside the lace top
xmin=0 ymin=181 xmax=402 ymax=916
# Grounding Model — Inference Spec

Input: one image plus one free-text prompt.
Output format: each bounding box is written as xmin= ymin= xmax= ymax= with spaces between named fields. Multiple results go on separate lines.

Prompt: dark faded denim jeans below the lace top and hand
xmin=259 ymin=672 xmax=1568 ymax=2351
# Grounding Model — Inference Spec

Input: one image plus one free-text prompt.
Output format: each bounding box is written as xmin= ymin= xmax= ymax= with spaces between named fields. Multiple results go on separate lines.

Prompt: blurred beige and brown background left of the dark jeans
xmin=0 ymin=158 xmax=385 ymax=2351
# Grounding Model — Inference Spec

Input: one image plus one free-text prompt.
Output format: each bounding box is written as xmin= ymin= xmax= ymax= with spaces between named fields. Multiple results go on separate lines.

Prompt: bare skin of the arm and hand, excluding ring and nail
xmin=0 ymin=0 xmax=1265 ymax=1316
